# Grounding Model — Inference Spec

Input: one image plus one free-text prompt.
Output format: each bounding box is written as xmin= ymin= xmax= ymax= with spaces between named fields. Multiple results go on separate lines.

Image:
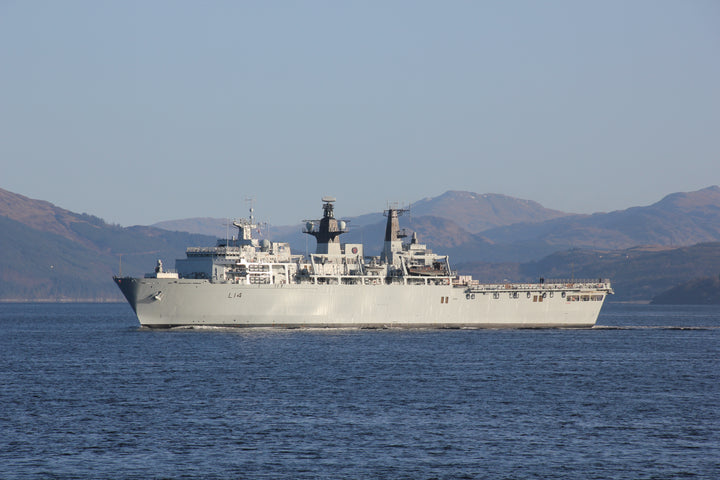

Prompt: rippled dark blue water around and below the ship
xmin=0 ymin=304 xmax=720 ymax=479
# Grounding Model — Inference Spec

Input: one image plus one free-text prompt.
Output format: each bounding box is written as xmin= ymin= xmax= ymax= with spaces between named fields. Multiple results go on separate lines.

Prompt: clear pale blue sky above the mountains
xmin=0 ymin=0 xmax=720 ymax=225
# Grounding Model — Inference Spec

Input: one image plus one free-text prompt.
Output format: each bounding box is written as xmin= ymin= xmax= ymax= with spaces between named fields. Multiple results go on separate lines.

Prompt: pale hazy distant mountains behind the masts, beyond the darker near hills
xmin=154 ymin=186 xmax=720 ymax=262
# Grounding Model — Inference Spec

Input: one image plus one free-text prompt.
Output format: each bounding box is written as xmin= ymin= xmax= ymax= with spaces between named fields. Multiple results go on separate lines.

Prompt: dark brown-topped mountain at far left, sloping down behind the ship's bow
xmin=0 ymin=189 xmax=214 ymax=301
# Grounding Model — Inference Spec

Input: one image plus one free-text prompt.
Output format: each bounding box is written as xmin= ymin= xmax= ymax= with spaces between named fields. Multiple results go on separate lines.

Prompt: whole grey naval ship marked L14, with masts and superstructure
xmin=114 ymin=197 xmax=613 ymax=328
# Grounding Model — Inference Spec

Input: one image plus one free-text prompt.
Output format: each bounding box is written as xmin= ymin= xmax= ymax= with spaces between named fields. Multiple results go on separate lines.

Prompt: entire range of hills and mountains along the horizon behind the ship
xmin=0 ymin=186 xmax=720 ymax=301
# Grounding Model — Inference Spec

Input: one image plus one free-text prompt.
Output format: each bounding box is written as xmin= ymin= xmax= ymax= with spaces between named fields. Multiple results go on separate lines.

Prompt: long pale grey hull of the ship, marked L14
xmin=115 ymin=277 xmax=608 ymax=328
